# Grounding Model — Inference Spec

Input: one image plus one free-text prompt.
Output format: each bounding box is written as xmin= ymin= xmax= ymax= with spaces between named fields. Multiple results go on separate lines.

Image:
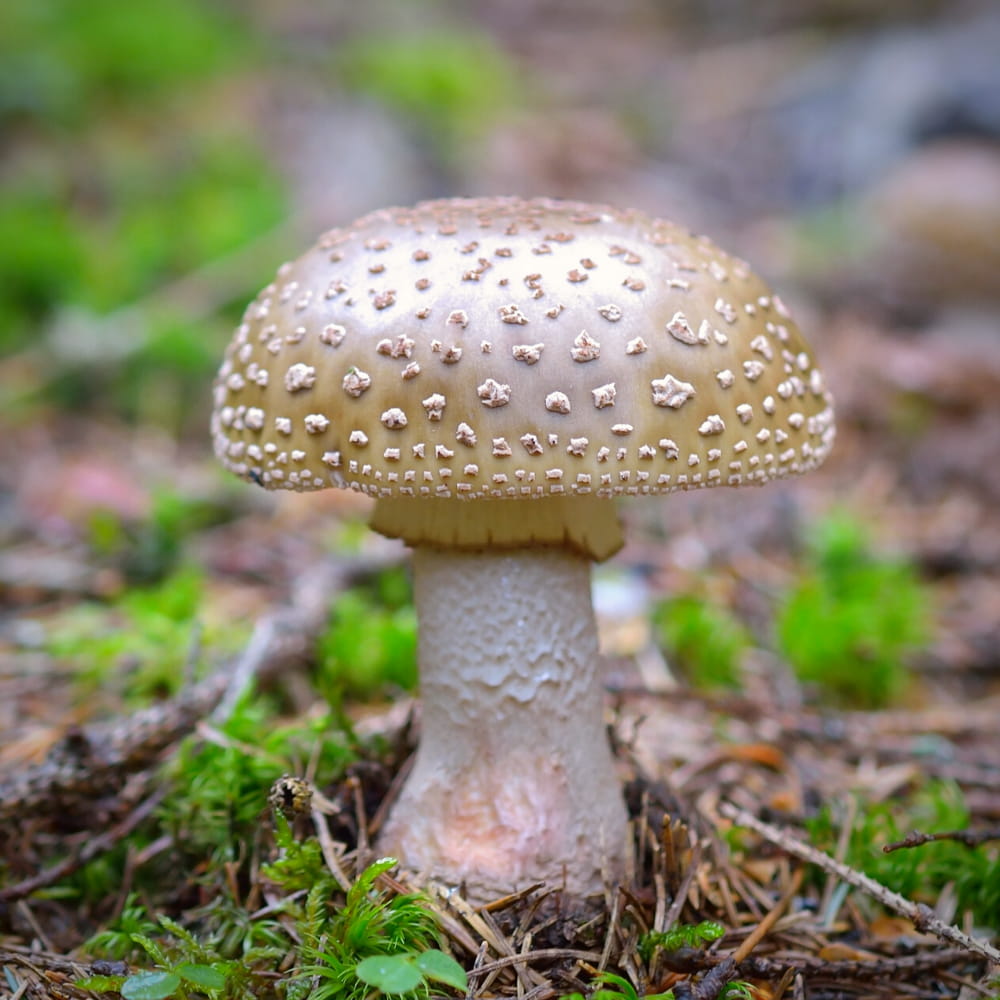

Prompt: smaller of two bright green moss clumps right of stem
xmin=653 ymin=594 xmax=750 ymax=689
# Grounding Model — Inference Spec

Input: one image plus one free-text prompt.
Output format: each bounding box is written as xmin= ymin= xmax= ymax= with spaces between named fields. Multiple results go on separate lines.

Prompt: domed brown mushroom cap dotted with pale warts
xmin=212 ymin=197 xmax=834 ymax=499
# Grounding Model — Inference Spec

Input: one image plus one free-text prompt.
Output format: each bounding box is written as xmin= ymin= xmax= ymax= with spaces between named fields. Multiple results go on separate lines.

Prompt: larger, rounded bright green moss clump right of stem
xmin=776 ymin=514 xmax=931 ymax=709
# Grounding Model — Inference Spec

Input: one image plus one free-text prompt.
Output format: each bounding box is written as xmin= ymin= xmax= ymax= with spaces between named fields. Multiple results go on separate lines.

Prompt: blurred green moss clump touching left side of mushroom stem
xmin=316 ymin=569 xmax=417 ymax=704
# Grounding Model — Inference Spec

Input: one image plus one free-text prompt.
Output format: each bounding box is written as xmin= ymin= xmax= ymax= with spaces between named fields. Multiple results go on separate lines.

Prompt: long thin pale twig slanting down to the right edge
xmin=719 ymin=802 xmax=1000 ymax=963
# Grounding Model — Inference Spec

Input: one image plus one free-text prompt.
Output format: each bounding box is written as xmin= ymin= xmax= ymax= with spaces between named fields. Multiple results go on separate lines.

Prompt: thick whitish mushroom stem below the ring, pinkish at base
xmin=380 ymin=547 xmax=626 ymax=901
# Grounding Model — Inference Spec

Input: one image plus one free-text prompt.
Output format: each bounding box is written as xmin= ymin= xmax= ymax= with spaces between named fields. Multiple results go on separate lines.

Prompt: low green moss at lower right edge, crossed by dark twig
xmin=807 ymin=781 xmax=1000 ymax=929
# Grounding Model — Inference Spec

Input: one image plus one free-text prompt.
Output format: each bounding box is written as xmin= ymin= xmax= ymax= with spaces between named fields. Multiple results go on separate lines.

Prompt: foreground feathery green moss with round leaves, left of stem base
xmin=86 ymin=852 xmax=460 ymax=1000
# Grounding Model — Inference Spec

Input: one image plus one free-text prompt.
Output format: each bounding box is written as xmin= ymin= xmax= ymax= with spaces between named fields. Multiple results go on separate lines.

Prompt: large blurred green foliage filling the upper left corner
xmin=0 ymin=0 xmax=285 ymax=420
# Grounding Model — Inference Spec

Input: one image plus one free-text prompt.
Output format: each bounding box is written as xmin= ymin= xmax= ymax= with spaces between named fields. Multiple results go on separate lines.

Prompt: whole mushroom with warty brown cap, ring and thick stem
xmin=212 ymin=198 xmax=834 ymax=901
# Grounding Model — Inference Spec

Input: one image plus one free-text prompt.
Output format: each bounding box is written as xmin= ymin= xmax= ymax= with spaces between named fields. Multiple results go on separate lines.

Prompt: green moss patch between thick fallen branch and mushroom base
xmin=62 ymin=695 xmax=358 ymax=912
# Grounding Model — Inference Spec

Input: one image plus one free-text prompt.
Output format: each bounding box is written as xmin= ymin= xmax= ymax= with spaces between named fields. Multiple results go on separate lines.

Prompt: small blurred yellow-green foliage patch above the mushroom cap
xmin=336 ymin=30 xmax=520 ymax=162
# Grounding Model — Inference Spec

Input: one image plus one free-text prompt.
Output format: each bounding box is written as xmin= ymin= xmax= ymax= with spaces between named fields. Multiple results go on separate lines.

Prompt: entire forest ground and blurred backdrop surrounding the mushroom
xmin=0 ymin=0 xmax=1000 ymax=1000
